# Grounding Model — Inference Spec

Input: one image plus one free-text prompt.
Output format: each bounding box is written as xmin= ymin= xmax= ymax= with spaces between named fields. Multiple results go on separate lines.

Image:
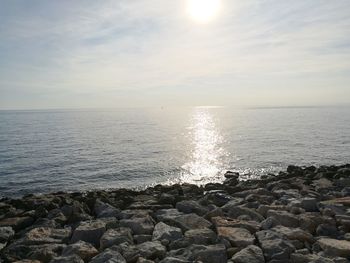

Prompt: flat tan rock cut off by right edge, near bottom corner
xmin=317 ymin=238 xmax=350 ymax=257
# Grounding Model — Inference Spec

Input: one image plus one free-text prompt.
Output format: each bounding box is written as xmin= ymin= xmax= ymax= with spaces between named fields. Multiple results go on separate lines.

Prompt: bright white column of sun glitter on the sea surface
xmin=181 ymin=107 xmax=227 ymax=184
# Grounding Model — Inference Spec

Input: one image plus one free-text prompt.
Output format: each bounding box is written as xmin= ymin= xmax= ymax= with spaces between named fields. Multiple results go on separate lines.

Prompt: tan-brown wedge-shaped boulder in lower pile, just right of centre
xmin=217 ymin=227 xmax=255 ymax=247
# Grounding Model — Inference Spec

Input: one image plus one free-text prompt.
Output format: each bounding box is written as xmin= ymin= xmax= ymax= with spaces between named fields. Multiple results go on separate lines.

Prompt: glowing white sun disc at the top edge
xmin=187 ymin=0 xmax=221 ymax=23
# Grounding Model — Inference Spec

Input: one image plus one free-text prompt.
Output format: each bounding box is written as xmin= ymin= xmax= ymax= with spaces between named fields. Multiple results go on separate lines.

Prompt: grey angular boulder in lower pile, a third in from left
xmin=100 ymin=227 xmax=133 ymax=249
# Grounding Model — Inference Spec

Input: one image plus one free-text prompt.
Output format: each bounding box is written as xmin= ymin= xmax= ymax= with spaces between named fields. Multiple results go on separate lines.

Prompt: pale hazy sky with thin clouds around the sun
xmin=0 ymin=0 xmax=350 ymax=109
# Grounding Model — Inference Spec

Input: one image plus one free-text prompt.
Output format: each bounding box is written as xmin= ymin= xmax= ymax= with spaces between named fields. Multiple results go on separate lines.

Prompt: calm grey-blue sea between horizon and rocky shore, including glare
xmin=0 ymin=107 xmax=350 ymax=196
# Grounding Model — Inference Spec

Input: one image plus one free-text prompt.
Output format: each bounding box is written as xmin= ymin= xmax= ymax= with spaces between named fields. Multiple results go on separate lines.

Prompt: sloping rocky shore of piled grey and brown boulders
xmin=0 ymin=165 xmax=350 ymax=263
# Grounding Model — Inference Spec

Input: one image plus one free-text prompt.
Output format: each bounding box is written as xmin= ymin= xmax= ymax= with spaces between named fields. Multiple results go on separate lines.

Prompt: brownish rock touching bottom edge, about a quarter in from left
xmin=62 ymin=240 xmax=98 ymax=262
